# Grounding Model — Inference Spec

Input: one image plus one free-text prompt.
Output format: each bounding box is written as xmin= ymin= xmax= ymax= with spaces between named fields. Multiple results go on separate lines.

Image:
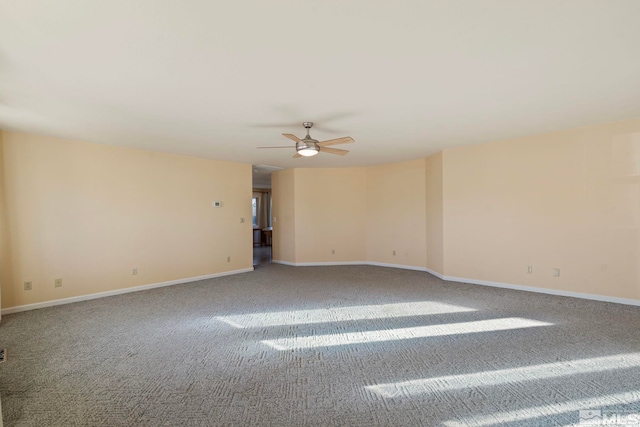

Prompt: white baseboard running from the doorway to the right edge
xmin=272 ymin=260 xmax=640 ymax=306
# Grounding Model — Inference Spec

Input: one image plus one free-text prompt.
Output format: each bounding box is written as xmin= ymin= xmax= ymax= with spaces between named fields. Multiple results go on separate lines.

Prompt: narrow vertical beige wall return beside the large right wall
xmin=425 ymin=153 xmax=444 ymax=274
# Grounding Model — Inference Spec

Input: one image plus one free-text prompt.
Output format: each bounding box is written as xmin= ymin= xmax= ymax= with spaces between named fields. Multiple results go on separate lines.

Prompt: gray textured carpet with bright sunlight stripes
xmin=0 ymin=264 xmax=640 ymax=427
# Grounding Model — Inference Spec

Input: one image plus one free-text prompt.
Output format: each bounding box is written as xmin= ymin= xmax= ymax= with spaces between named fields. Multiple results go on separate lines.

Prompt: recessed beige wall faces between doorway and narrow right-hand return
xmin=272 ymin=159 xmax=426 ymax=267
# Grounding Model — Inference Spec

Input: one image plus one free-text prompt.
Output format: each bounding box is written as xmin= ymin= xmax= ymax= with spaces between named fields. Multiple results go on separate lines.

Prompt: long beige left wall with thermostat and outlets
xmin=2 ymin=132 xmax=252 ymax=307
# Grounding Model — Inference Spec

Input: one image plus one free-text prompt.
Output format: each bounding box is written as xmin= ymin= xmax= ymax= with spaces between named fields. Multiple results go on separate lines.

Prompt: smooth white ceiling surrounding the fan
xmin=0 ymin=0 xmax=640 ymax=171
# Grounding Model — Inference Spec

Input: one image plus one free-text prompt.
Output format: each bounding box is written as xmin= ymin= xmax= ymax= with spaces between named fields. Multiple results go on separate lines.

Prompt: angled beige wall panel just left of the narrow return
xmin=363 ymin=159 xmax=427 ymax=268
